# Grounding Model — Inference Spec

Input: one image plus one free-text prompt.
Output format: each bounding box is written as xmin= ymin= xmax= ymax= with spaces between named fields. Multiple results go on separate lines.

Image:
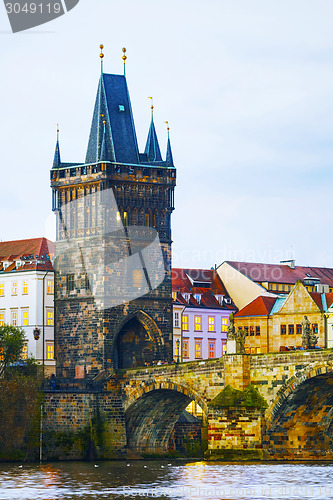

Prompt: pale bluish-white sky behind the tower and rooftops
xmin=0 ymin=0 xmax=333 ymax=268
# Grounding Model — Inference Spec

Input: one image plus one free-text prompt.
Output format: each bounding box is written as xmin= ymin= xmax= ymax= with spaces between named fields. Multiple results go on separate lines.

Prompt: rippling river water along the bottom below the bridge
xmin=0 ymin=461 xmax=333 ymax=500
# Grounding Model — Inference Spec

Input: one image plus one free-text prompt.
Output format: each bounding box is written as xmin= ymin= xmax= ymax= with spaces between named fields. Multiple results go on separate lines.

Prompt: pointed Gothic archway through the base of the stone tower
xmin=112 ymin=310 xmax=164 ymax=369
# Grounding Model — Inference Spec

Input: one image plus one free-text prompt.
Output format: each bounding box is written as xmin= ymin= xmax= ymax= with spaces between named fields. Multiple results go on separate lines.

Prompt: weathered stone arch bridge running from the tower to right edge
xmin=44 ymin=349 xmax=333 ymax=460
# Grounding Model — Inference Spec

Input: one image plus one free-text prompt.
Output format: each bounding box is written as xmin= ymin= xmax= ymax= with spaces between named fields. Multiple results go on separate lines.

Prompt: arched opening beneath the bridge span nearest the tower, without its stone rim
xmin=125 ymin=389 xmax=202 ymax=456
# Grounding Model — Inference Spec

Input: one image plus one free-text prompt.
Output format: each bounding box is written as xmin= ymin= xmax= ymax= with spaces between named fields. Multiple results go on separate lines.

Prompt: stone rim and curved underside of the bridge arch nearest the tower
xmin=124 ymin=381 xmax=207 ymax=454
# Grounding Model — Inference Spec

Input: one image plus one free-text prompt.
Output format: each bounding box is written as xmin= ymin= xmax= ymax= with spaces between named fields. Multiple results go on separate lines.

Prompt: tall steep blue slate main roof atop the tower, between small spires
xmin=86 ymin=73 xmax=139 ymax=164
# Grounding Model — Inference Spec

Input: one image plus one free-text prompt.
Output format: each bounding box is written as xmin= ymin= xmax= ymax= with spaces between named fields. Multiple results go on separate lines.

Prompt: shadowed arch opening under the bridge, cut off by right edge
xmin=264 ymin=373 xmax=333 ymax=460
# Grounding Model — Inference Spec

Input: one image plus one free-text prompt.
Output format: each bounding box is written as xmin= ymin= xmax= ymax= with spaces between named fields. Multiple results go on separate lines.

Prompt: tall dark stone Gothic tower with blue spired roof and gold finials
xmin=51 ymin=46 xmax=176 ymax=382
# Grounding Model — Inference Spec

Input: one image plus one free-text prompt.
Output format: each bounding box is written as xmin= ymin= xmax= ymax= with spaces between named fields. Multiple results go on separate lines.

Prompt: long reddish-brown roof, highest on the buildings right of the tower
xmin=226 ymin=261 xmax=333 ymax=287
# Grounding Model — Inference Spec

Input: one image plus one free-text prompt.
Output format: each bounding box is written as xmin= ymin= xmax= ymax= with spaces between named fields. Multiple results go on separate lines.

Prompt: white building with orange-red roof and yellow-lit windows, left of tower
xmin=0 ymin=238 xmax=55 ymax=374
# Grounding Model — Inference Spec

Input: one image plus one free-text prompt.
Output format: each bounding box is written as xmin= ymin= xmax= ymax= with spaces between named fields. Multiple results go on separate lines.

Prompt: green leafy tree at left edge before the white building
xmin=0 ymin=325 xmax=26 ymax=377
